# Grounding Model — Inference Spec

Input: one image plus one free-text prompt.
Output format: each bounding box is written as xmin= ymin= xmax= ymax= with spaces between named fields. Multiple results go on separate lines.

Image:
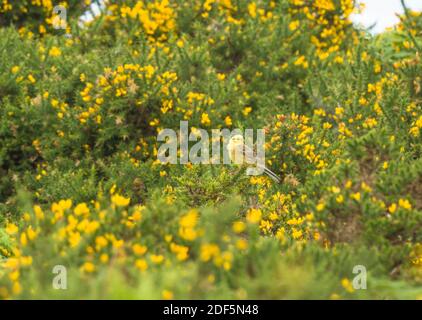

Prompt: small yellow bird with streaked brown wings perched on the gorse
xmin=227 ymin=134 xmax=280 ymax=183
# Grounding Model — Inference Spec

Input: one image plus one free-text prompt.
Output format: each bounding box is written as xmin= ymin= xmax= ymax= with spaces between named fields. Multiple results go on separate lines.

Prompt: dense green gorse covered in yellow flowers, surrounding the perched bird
xmin=0 ymin=0 xmax=422 ymax=299
